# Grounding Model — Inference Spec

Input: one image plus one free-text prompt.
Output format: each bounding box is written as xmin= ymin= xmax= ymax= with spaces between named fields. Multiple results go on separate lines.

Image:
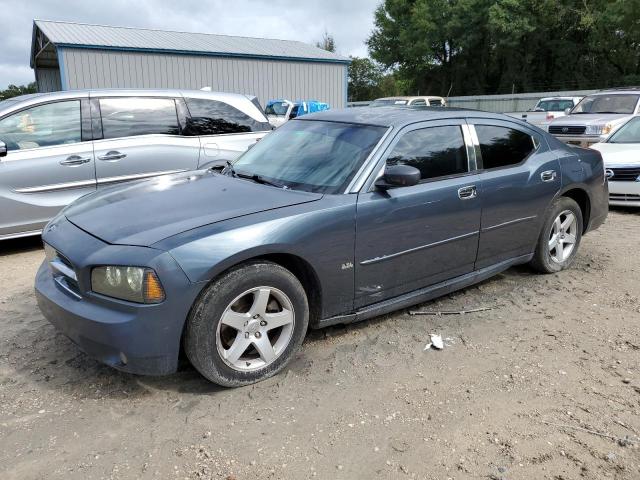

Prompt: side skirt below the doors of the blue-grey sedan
xmin=313 ymin=253 xmax=533 ymax=328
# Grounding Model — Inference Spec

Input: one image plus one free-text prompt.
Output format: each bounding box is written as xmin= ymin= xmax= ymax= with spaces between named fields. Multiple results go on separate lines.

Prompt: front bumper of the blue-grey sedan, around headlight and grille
xmin=35 ymin=219 xmax=199 ymax=375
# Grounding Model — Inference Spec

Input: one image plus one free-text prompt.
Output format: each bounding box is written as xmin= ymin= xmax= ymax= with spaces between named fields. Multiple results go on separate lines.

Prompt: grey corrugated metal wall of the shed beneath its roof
xmin=58 ymin=48 xmax=347 ymax=108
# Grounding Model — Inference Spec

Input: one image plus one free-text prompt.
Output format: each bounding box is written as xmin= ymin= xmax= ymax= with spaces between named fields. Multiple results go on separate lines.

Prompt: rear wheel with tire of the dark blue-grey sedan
xmin=531 ymin=197 xmax=583 ymax=273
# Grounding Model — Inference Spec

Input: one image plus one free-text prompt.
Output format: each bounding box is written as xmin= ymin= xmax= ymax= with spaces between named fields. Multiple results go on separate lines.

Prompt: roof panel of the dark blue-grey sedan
xmin=296 ymin=106 xmax=528 ymax=127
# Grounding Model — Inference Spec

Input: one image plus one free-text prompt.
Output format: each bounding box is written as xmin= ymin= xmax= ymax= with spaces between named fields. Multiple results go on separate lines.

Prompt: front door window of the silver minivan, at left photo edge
xmin=0 ymin=100 xmax=82 ymax=150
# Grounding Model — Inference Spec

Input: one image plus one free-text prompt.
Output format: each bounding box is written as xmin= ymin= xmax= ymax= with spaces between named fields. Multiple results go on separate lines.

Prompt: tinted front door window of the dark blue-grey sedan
xmin=387 ymin=125 xmax=469 ymax=181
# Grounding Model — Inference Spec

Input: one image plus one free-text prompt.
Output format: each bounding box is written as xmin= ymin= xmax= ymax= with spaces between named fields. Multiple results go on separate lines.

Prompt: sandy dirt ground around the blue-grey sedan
xmin=0 ymin=210 xmax=640 ymax=480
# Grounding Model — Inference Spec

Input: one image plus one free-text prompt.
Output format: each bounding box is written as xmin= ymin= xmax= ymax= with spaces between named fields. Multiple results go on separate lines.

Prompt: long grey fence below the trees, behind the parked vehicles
xmin=447 ymin=90 xmax=596 ymax=113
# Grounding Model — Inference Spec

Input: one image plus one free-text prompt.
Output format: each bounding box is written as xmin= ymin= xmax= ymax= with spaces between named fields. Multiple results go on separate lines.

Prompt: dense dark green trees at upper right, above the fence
xmin=367 ymin=0 xmax=640 ymax=95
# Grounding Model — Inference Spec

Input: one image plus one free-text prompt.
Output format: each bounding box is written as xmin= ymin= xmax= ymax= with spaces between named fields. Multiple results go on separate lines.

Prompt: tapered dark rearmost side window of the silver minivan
xmin=184 ymin=98 xmax=271 ymax=135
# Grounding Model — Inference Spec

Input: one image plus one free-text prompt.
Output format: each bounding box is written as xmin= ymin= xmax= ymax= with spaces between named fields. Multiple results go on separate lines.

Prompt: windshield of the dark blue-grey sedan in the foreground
xmin=233 ymin=120 xmax=386 ymax=193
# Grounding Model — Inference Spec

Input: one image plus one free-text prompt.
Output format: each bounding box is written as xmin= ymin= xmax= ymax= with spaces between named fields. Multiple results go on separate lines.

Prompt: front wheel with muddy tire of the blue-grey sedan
xmin=185 ymin=261 xmax=309 ymax=387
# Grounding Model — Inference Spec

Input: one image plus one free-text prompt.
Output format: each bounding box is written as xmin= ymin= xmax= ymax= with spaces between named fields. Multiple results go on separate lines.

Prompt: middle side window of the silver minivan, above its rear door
xmin=100 ymin=97 xmax=180 ymax=138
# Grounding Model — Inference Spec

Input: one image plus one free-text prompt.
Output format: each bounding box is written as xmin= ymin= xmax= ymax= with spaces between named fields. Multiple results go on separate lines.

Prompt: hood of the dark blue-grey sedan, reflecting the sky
xmin=64 ymin=171 xmax=322 ymax=246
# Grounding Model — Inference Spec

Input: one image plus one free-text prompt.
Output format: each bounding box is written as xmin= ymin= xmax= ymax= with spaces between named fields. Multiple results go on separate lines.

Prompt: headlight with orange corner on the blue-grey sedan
xmin=91 ymin=265 xmax=165 ymax=303
